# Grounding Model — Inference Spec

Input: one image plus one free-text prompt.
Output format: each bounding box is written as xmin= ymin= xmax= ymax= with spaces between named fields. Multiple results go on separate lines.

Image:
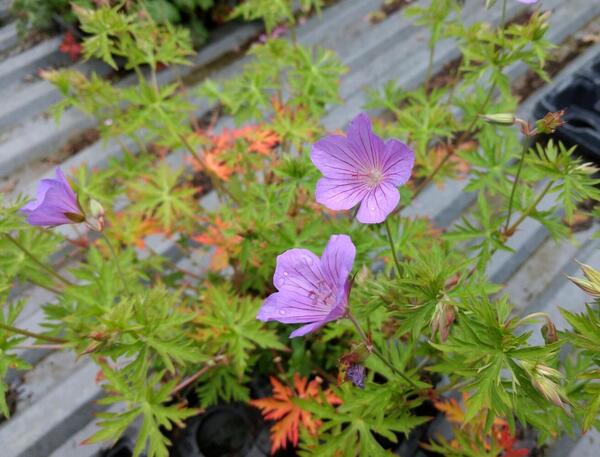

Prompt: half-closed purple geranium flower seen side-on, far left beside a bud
xmin=21 ymin=167 xmax=85 ymax=227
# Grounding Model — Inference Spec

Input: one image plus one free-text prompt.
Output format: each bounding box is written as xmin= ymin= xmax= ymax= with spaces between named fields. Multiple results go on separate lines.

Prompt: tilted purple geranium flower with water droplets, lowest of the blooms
xmin=256 ymin=235 xmax=356 ymax=338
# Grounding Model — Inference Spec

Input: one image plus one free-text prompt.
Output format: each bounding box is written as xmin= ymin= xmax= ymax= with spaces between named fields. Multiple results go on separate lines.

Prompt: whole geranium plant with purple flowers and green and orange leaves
xmin=0 ymin=0 xmax=600 ymax=457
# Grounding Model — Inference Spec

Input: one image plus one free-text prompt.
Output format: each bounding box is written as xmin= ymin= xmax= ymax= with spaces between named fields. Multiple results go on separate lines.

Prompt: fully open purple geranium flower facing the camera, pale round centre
xmin=311 ymin=113 xmax=415 ymax=224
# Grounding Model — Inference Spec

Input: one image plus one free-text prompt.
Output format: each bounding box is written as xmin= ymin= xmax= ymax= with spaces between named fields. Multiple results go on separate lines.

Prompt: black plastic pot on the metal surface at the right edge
xmin=535 ymin=56 xmax=600 ymax=163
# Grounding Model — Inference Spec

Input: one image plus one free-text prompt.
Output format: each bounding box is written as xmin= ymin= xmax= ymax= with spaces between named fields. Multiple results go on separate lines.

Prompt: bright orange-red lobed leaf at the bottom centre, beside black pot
xmin=250 ymin=373 xmax=342 ymax=454
